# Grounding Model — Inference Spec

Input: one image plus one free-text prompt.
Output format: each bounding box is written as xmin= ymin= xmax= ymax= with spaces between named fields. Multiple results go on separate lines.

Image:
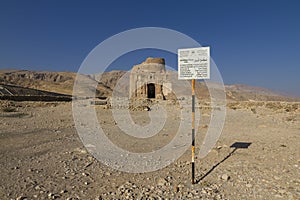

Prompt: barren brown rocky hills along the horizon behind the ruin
xmin=0 ymin=70 xmax=300 ymax=101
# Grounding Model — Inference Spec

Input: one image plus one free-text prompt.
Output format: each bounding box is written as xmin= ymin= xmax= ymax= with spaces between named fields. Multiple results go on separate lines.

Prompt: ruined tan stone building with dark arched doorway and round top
xmin=129 ymin=58 xmax=172 ymax=99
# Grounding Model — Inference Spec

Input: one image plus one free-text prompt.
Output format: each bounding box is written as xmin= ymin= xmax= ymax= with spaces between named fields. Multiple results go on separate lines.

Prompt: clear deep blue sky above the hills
xmin=0 ymin=0 xmax=300 ymax=96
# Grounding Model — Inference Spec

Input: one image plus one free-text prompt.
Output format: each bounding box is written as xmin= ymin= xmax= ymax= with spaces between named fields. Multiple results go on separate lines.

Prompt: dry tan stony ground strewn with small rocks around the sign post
xmin=0 ymin=101 xmax=300 ymax=200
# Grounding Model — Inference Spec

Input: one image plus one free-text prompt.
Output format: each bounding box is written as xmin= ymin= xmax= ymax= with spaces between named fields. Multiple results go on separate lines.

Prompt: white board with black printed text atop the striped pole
xmin=178 ymin=47 xmax=210 ymax=80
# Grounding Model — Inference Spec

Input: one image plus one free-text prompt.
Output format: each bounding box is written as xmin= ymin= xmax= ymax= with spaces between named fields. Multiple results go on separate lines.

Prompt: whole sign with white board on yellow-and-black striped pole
xmin=178 ymin=47 xmax=210 ymax=184
